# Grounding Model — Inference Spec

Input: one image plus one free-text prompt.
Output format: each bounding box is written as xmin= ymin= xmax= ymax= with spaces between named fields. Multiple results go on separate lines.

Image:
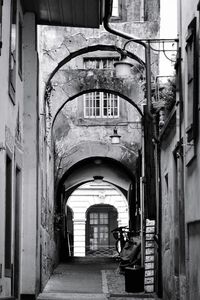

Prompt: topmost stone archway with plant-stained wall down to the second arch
xmin=44 ymin=45 xmax=144 ymax=142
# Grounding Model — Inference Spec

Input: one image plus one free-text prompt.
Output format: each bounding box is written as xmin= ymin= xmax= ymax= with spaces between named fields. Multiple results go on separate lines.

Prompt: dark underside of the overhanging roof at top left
xmin=22 ymin=0 xmax=105 ymax=28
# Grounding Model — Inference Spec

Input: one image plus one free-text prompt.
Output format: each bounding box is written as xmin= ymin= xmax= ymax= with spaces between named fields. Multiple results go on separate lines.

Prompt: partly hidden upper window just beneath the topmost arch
xmin=83 ymin=57 xmax=119 ymax=69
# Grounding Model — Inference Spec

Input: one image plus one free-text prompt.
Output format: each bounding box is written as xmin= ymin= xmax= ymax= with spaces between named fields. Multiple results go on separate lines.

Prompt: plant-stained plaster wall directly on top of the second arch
xmin=49 ymin=69 xmax=144 ymax=120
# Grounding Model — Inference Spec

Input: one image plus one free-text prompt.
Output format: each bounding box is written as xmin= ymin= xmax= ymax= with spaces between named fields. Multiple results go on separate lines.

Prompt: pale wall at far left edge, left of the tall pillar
xmin=0 ymin=0 xmax=23 ymax=297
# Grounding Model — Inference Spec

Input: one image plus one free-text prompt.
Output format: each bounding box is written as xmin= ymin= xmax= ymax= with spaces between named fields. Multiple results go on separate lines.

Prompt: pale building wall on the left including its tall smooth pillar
xmin=0 ymin=0 xmax=50 ymax=299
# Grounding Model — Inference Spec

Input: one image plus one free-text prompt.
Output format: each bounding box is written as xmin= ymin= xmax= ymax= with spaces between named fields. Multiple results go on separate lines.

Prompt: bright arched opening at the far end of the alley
xmin=65 ymin=181 xmax=129 ymax=260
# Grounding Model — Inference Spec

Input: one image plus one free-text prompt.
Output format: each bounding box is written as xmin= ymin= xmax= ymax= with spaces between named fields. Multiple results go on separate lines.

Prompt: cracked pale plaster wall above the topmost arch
xmin=39 ymin=8 xmax=159 ymax=81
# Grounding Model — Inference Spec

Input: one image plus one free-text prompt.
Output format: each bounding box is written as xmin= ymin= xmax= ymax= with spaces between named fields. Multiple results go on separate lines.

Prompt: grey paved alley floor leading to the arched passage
xmin=38 ymin=259 xmax=157 ymax=300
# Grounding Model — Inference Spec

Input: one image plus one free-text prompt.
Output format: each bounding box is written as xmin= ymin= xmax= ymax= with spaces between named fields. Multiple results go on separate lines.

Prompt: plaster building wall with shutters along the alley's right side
xmin=161 ymin=0 xmax=200 ymax=300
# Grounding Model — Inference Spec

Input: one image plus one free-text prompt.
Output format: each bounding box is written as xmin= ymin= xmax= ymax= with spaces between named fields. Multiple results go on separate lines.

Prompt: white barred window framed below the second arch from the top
xmin=84 ymin=92 xmax=119 ymax=118
